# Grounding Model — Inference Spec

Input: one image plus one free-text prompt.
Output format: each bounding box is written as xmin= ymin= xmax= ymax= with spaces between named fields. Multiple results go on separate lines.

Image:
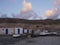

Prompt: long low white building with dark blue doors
xmin=0 ymin=28 xmax=31 ymax=35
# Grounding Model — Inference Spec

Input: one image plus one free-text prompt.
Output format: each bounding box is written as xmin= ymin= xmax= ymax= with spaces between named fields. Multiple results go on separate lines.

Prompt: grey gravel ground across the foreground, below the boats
xmin=0 ymin=36 xmax=60 ymax=45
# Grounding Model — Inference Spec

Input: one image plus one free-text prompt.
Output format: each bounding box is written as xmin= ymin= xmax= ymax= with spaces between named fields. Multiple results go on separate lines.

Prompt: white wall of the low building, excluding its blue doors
xmin=0 ymin=28 xmax=31 ymax=35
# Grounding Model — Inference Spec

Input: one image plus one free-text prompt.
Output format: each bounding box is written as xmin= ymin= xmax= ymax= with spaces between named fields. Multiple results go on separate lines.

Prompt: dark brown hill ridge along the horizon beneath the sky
xmin=0 ymin=18 xmax=60 ymax=25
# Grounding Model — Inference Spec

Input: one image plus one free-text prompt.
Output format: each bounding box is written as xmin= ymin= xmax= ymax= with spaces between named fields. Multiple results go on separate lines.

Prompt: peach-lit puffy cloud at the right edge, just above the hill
xmin=45 ymin=8 xmax=60 ymax=19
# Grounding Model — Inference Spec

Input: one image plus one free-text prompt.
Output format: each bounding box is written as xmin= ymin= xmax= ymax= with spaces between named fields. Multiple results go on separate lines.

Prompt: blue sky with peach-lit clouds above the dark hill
xmin=0 ymin=0 xmax=60 ymax=19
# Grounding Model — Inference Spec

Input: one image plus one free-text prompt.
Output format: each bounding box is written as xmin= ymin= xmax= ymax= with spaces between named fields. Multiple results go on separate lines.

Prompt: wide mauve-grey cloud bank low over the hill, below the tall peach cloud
xmin=12 ymin=10 xmax=42 ymax=20
